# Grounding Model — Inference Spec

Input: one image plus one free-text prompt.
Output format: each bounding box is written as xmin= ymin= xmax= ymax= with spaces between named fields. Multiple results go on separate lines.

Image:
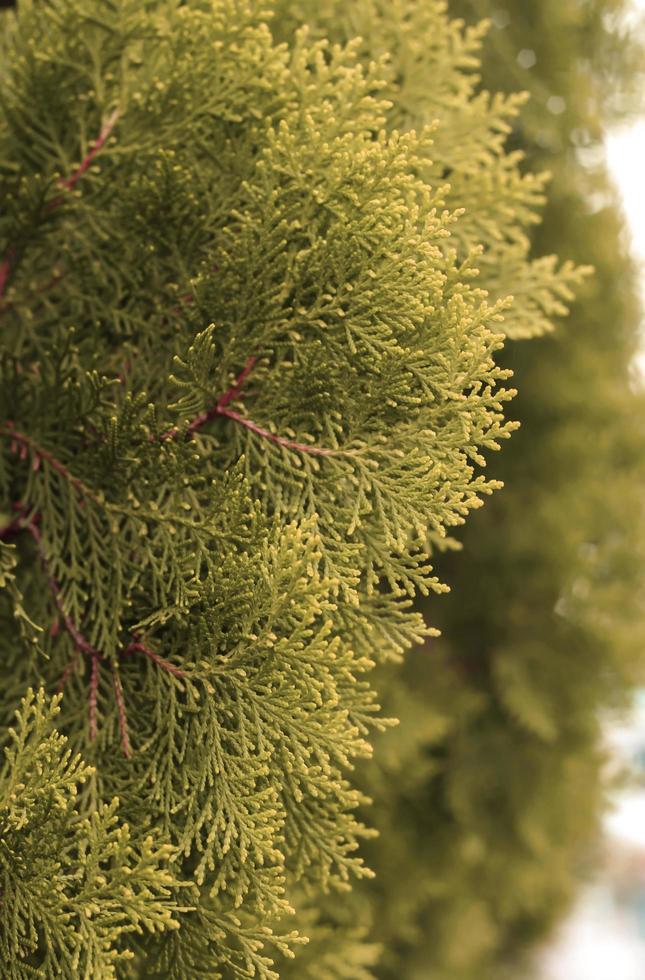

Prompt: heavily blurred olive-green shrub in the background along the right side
xmin=280 ymin=0 xmax=645 ymax=980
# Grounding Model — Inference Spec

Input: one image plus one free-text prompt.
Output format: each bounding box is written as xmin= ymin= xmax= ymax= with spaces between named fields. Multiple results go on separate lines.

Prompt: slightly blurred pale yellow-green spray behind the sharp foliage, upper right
xmin=278 ymin=0 xmax=584 ymax=338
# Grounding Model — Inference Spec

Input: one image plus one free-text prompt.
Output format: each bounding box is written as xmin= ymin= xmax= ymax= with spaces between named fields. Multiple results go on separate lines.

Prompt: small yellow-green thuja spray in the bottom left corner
xmin=0 ymin=690 xmax=179 ymax=980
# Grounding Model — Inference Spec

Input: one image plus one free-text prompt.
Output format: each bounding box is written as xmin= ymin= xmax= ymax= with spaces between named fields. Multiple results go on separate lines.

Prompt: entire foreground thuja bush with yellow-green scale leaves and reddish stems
xmin=0 ymin=0 xmax=580 ymax=980
